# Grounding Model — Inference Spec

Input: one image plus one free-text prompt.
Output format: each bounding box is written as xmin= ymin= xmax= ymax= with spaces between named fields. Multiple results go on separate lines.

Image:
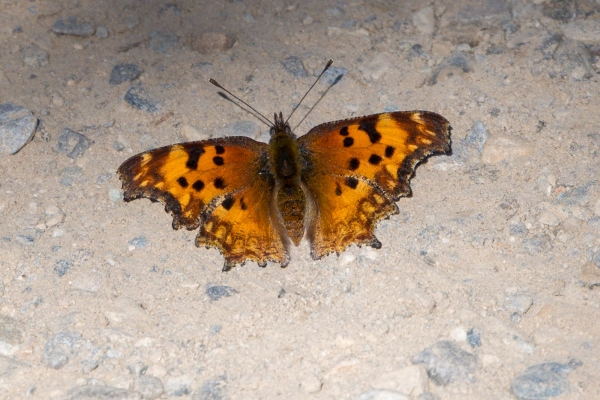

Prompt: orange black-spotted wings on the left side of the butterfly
xmin=118 ymin=137 xmax=289 ymax=270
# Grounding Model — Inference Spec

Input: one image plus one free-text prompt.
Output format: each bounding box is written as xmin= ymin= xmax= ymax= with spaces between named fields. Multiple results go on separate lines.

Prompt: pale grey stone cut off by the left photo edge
xmin=0 ymin=103 xmax=38 ymax=154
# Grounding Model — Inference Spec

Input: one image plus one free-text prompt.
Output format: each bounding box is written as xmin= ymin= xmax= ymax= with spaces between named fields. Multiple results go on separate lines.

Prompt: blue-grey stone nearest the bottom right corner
xmin=510 ymin=360 xmax=582 ymax=400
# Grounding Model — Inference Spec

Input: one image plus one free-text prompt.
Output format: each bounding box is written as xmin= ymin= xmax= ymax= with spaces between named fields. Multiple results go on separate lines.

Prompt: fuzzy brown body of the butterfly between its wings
xmin=269 ymin=113 xmax=306 ymax=245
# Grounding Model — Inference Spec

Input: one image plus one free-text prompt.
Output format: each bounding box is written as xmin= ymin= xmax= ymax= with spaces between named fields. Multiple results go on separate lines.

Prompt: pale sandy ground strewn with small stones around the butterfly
xmin=0 ymin=0 xmax=600 ymax=400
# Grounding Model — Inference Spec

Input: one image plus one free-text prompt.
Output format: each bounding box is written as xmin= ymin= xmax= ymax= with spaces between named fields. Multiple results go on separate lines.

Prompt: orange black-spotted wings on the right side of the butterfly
xmin=298 ymin=111 xmax=450 ymax=259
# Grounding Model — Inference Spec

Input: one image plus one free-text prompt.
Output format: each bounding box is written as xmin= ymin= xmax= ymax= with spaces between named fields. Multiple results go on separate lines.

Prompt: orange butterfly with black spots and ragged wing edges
xmin=118 ymin=64 xmax=450 ymax=271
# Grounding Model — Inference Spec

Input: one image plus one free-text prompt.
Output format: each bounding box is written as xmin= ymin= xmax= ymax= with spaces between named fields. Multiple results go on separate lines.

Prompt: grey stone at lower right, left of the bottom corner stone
xmin=412 ymin=340 xmax=479 ymax=386
